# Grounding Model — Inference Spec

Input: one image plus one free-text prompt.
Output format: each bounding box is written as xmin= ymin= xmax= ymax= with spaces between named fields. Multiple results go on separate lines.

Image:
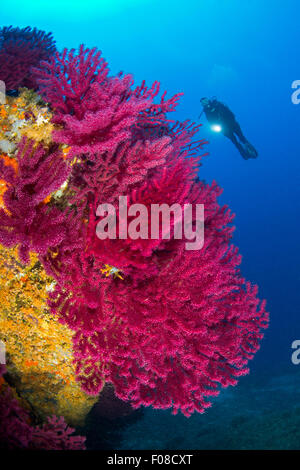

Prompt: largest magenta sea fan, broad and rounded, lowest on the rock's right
xmin=63 ymin=154 xmax=268 ymax=416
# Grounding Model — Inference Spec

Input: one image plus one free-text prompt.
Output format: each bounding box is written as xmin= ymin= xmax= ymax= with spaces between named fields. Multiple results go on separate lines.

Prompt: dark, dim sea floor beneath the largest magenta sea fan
xmin=81 ymin=366 xmax=300 ymax=450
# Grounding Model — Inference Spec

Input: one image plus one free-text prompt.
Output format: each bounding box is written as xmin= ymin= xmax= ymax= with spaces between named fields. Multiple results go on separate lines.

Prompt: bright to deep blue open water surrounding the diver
xmin=0 ymin=0 xmax=300 ymax=449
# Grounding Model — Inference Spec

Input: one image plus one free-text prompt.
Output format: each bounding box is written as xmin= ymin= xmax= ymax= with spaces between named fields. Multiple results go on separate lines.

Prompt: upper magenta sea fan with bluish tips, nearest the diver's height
xmin=33 ymin=45 xmax=180 ymax=157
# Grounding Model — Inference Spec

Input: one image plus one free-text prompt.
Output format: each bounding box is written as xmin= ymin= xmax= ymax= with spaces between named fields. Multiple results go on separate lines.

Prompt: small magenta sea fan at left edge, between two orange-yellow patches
xmin=0 ymin=138 xmax=69 ymax=263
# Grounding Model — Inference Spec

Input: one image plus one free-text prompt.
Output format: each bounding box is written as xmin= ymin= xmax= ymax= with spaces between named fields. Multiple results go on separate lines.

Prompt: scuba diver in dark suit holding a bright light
xmin=199 ymin=97 xmax=258 ymax=160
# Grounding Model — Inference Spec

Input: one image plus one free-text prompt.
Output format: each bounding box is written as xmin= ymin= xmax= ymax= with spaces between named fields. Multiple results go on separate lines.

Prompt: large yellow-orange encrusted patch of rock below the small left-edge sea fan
xmin=0 ymin=245 xmax=96 ymax=425
